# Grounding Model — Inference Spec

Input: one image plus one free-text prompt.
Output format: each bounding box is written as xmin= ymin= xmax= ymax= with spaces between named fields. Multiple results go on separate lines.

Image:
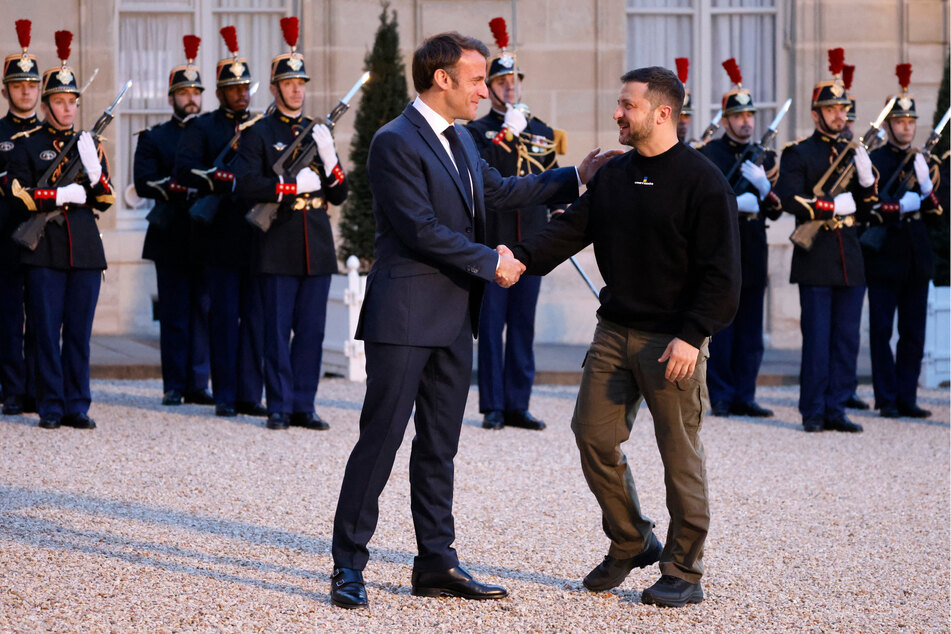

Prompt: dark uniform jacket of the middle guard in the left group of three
xmin=173 ymin=106 xmax=251 ymax=270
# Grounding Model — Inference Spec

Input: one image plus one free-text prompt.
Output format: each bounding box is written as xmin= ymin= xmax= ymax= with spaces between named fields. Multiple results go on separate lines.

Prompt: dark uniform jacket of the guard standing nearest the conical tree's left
xmin=235 ymin=108 xmax=347 ymax=275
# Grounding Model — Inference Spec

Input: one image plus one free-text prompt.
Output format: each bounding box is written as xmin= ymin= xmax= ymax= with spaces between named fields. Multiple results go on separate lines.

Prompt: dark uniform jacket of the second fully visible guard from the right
xmin=775 ymin=130 xmax=878 ymax=286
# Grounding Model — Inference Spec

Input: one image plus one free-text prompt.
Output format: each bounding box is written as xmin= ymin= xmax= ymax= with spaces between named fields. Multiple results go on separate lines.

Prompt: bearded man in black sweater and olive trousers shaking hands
xmin=512 ymin=67 xmax=740 ymax=607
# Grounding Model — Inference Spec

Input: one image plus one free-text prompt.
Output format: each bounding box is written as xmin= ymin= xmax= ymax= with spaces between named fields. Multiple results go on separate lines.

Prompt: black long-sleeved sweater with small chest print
xmin=513 ymin=143 xmax=740 ymax=348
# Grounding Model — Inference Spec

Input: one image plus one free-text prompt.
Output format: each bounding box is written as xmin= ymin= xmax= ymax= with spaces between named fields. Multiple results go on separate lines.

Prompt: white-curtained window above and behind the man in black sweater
xmin=627 ymin=0 xmax=780 ymax=143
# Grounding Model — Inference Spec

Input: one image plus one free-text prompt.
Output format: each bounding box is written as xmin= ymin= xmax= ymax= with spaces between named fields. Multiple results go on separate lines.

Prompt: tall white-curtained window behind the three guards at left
xmin=114 ymin=0 xmax=297 ymax=230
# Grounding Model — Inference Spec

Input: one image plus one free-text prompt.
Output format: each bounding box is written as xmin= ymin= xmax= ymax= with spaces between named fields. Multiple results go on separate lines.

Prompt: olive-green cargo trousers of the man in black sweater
xmin=571 ymin=318 xmax=710 ymax=583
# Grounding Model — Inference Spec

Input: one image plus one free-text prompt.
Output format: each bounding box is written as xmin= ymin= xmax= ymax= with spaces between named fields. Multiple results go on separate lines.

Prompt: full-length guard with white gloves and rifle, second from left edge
xmin=7 ymin=31 xmax=115 ymax=429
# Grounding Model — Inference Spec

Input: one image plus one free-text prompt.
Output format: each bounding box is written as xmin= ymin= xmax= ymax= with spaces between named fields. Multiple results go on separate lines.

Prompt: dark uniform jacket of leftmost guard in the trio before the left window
xmin=138 ymin=116 xmax=194 ymax=268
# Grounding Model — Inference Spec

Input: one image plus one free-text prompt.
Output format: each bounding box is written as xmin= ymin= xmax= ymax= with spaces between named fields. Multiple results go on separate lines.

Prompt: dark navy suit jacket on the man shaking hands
xmin=357 ymin=104 xmax=578 ymax=347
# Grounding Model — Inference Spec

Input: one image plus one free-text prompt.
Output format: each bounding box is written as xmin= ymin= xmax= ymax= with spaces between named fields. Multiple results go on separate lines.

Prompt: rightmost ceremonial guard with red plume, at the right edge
xmin=862 ymin=64 xmax=942 ymax=418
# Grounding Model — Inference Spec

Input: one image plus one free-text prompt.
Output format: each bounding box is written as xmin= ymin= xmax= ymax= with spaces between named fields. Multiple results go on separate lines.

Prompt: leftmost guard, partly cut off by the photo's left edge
xmin=0 ymin=20 xmax=40 ymax=416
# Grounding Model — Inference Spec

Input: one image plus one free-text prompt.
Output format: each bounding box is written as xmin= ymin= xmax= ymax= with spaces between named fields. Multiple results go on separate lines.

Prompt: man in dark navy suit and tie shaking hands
xmin=330 ymin=32 xmax=613 ymax=608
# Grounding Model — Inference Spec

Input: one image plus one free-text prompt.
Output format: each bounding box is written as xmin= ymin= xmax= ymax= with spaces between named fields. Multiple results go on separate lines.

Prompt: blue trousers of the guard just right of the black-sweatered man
xmin=707 ymin=286 xmax=766 ymax=405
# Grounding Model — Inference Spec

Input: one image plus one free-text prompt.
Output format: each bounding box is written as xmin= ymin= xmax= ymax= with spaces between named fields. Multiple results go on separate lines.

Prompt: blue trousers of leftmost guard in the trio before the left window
xmin=155 ymin=262 xmax=210 ymax=392
